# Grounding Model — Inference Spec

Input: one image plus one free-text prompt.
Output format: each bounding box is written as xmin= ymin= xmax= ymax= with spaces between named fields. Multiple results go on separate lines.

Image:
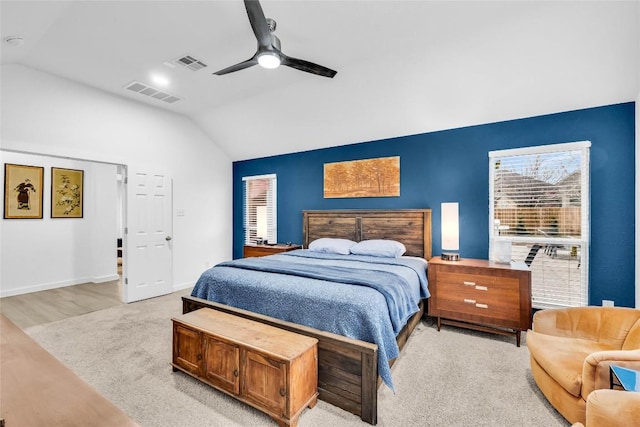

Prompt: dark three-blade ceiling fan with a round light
xmin=214 ymin=0 xmax=337 ymax=78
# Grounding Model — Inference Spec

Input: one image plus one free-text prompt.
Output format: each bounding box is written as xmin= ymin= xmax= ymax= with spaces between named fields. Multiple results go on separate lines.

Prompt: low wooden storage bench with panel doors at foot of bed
xmin=172 ymin=308 xmax=318 ymax=427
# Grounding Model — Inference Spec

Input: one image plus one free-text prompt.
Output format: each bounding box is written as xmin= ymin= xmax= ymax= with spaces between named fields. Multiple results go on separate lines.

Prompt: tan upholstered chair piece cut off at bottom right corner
xmin=586 ymin=390 xmax=640 ymax=427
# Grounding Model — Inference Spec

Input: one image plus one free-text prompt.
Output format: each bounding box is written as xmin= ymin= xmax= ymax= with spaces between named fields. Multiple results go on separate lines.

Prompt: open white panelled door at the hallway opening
xmin=122 ymin=170 xmax=173 ymax=303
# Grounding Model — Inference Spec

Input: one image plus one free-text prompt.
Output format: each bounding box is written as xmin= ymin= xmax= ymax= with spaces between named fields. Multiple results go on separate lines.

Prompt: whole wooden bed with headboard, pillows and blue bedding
xmin=183 ymin=209 xmax=431 ymax=424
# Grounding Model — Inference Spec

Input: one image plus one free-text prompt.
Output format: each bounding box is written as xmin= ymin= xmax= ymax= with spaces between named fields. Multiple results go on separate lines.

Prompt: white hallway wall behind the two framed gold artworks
xmin=0 ymin=152 xmax=118 ymax=297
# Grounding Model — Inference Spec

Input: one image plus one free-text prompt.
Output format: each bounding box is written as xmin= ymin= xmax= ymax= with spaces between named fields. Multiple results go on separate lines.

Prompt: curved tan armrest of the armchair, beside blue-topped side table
xmin=580 ymin=350 xmax=640 ymax=399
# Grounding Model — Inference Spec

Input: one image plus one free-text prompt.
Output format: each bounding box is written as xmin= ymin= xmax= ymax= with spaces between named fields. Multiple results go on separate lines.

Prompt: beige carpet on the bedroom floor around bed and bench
xmin=27 ymin=292 xmax=569 ymax=427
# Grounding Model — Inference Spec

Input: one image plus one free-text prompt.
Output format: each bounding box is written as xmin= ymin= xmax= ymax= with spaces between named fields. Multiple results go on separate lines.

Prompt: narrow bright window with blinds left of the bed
xmin=242 ymin=174 xmax=278 ymax=244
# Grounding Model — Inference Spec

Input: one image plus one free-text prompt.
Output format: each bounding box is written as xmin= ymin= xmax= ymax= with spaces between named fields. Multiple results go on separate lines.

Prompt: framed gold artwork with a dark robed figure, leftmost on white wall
xmin=4 ymin=163 xmax=44 ymax=219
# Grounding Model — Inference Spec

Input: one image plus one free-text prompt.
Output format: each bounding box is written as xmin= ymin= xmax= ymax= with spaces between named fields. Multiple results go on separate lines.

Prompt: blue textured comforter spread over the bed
xmin=191 ymin=250 xmax=429 ymax=389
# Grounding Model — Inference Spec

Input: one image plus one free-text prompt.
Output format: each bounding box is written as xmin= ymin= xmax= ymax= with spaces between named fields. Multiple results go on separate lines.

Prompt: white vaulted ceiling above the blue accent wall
xmin=0 ymin=0 xmax=640 ymax=160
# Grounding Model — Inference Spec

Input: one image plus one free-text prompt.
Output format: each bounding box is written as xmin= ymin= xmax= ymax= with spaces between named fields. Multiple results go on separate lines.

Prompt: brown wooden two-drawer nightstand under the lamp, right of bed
xmin=428 ymin=257 xmax=531 ymax=347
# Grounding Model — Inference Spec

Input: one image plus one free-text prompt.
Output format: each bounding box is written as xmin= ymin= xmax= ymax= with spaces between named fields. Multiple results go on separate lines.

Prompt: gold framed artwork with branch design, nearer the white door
xmin=51 ymin=168 xmax=84 ymax=218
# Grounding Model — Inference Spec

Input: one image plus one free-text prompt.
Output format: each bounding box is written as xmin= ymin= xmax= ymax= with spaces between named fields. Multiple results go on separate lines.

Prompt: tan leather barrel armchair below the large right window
xmin=526 ymin=307 xmax=640 ymax=427
